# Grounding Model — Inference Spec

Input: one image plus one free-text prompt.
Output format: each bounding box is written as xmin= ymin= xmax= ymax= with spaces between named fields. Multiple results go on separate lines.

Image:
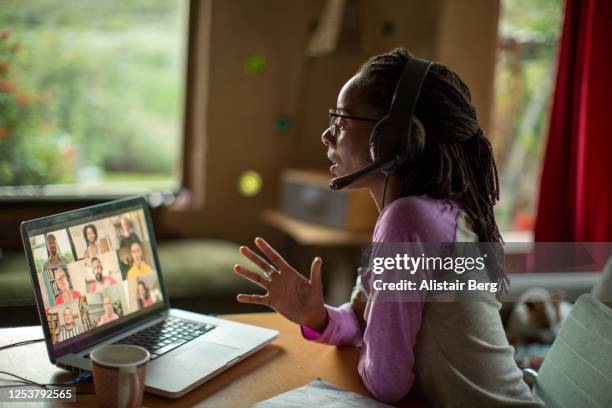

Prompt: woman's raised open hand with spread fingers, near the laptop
xmin=234 ymin=238 xmax=327 ymax=332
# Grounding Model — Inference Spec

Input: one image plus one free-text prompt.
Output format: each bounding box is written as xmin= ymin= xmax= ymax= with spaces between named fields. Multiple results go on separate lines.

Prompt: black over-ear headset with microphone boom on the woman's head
xmin=329 ymin=57 xmax=431 ymax=190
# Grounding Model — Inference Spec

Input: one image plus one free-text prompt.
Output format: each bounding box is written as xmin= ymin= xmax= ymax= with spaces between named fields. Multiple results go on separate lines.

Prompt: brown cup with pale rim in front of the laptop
xmin=89 ymin=344 xmax=151 ymax=408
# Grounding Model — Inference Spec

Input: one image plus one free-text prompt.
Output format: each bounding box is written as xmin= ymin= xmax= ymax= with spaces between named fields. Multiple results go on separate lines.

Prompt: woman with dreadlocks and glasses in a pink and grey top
xmin=234 ymin=48 xmax=540 ymax=407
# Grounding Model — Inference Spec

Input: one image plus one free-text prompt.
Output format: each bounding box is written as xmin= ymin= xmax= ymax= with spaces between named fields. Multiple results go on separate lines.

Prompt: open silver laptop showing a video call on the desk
xmin=21 ymin=197 xmax=278 ymax=398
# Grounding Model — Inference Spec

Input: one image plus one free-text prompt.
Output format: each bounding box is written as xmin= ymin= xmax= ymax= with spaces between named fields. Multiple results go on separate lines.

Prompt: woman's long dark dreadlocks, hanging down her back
xmin=356 ymin=48 xmax=509 ymax=294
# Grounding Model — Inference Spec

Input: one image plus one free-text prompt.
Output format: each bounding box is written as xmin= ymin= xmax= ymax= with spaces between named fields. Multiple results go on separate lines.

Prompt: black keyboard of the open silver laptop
xmin=115 ymin=317 xmax=217 ymax=360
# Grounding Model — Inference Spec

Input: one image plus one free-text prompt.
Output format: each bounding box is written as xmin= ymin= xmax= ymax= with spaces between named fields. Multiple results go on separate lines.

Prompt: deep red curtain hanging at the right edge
xmin=535 ymin=0 xmax=612 ymax=242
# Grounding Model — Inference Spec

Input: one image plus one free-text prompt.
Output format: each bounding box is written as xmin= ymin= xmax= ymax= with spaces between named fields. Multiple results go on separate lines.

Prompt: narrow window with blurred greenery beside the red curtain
xmin=492 ymin=0 xmax=563 ymax=231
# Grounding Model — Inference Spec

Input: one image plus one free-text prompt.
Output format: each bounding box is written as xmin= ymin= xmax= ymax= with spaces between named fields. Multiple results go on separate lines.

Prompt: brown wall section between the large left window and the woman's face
xmin=161 ymin=0 xmax=322 ymax=241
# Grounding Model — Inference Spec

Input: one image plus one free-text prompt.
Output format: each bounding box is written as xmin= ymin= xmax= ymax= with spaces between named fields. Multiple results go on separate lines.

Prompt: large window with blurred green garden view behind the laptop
xmin=0 ymin=0 xmax=188 ymax=197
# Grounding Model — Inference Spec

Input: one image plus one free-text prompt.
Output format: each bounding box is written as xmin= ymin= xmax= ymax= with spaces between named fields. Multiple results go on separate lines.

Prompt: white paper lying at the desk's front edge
xmin=251 ymin=378 xmax=390 ymax=408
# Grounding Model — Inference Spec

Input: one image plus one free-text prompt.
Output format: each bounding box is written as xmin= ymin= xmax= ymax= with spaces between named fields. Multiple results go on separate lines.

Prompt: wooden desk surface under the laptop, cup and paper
xmin=0 ymin=313 xmax=424 ymax=408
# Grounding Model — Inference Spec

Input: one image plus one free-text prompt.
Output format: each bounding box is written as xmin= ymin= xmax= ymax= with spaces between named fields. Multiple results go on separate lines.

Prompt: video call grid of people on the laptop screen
xmin=28 ymin=208 xmax=163 ymax=345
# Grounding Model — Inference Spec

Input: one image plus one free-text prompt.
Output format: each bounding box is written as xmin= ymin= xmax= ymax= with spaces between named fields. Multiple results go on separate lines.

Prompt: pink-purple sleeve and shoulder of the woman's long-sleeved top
xmin=301 ymin=196 xmax=459 ymax=403
